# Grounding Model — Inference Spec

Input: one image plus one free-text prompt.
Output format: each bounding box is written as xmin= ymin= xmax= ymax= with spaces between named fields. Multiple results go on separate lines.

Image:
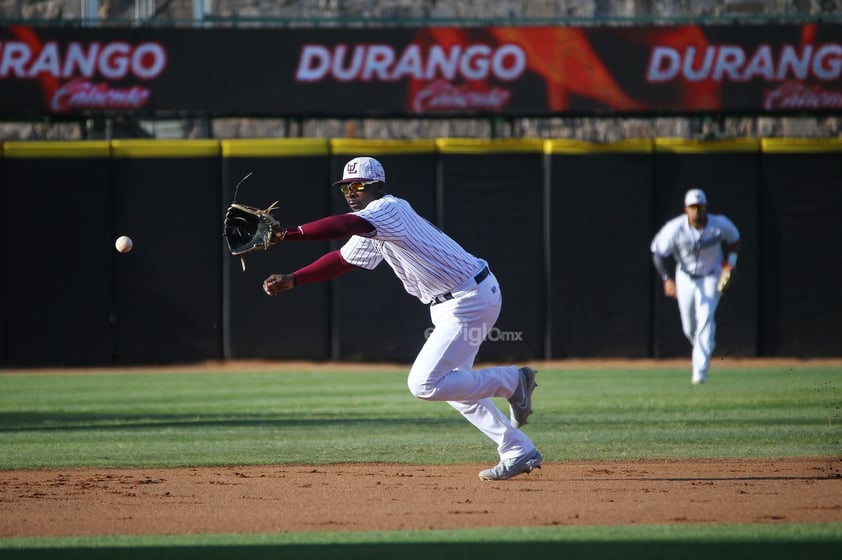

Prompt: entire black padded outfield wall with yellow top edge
xmin=0 ymin=138 xmax=842 ymax=368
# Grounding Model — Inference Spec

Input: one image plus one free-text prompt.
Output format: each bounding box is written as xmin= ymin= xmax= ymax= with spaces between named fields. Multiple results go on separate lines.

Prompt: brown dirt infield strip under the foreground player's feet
xmin=0 ymin=458 xmax=842 ymax=537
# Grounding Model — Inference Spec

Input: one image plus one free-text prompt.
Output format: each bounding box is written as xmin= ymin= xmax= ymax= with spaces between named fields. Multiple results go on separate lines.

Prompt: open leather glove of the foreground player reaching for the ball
xmin=224 ymin=201 xmax=286 ymax=270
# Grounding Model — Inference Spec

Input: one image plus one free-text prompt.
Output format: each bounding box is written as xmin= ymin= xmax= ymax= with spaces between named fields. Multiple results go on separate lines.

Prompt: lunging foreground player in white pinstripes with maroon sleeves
xmin=263 ymin=157 xmax=542 ymax=480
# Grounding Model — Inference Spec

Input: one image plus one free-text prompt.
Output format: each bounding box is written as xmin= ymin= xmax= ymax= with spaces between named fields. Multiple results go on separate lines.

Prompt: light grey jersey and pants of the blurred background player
xmin=650 ymin=207 xmax=740 ymax=383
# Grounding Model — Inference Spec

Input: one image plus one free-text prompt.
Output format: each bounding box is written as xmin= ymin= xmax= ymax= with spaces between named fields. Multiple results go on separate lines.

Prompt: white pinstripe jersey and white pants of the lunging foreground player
xmin=340 ymin=195 xmax=535 ymax=459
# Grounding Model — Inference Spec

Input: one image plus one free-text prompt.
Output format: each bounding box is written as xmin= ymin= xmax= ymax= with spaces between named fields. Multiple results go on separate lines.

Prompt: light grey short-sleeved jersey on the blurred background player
xmin=650 ymin=214 xmax=740 ymax=276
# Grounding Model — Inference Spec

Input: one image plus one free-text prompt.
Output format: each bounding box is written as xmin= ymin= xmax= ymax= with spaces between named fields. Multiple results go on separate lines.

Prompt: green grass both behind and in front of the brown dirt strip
xmin=0 ymin=364 xmax=842 ymax=560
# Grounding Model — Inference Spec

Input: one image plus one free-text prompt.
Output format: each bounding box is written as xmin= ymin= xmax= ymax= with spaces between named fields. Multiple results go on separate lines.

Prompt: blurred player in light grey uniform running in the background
xmin=650 ymin=189 xmax=740 ymax=385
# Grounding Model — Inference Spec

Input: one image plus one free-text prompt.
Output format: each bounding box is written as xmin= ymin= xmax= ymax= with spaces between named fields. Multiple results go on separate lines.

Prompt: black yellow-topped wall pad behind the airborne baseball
xmin=110 ymin=140 xmax=223 ymax=363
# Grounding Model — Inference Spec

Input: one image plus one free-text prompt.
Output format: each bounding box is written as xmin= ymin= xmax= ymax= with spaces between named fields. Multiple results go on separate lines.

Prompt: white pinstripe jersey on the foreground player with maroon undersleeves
xmin=340 ymin=195 xmax=485 ymax=303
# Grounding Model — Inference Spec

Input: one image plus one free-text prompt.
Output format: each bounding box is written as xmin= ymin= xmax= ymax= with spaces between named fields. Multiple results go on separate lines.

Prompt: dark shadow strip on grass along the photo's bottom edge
xmin=0 ymin=541 xmax=842 ymax=560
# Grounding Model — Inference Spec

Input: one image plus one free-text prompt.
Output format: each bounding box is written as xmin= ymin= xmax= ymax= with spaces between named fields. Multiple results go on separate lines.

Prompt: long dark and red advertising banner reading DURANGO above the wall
xmin=0 ymin=23 xmax=842 ymax=118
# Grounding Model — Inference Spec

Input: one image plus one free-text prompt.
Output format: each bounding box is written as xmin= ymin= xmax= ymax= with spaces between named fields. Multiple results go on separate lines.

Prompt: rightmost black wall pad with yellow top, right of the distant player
xmin=758 ymin=139 xmax=842 ymax=357
